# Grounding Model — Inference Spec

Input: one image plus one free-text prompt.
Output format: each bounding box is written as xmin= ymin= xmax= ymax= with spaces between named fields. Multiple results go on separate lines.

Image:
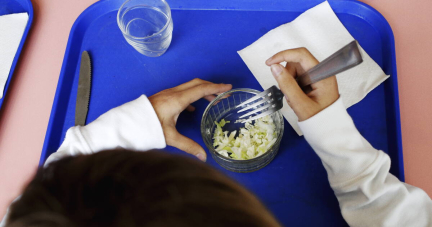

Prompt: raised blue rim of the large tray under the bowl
xmin=39 ymin=0 xmax=405 ymax=182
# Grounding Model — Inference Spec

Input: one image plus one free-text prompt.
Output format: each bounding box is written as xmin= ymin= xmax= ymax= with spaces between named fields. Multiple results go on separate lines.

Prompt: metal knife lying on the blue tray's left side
xmin=75 ymin=51 xmax=91 ymax=126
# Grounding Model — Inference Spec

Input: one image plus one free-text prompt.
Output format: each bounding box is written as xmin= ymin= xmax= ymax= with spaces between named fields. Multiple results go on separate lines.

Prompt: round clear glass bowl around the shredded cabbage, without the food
xmin=201 ymin=88 xmax=284 ymax=173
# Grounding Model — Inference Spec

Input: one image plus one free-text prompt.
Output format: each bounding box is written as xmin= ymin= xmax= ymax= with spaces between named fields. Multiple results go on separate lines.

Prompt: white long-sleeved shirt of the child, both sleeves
xmin=0 ymin=96 xmax=432 ymax=227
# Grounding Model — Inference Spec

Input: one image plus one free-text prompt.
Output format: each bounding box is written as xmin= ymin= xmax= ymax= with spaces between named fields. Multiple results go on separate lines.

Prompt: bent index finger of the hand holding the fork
xmin=266 ymin=47 xmax=318 ymax=71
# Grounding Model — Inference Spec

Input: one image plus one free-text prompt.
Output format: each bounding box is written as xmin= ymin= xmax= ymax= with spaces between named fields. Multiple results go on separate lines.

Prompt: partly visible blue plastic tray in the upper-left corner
xmin=0 ymin=0 xmax=33 ymax=109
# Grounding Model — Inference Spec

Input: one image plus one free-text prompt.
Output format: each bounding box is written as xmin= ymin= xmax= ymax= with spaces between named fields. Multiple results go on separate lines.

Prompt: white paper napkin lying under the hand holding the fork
xmin=238 ymin=2 xmax=389 ymax=135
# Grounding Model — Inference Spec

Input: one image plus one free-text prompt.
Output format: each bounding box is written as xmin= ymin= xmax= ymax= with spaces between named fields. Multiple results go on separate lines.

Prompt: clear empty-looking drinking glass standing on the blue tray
xmin=117 ymin=0 xmax=173 ymax=57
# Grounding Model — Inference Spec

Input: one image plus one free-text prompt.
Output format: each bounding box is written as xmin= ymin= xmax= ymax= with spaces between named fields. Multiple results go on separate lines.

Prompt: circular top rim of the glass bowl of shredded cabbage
xmin=200 ymin=88 xmax=284 ymax=163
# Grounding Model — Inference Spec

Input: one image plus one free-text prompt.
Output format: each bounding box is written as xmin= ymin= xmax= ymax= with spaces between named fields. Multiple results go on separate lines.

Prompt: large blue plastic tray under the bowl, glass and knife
xmin=41 ymin=0 xmax=404 ymax=226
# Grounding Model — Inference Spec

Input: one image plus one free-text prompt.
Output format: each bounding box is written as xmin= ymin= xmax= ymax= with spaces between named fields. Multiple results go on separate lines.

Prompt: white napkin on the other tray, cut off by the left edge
xmin=0 ymin=13 xmax=28 ymax=99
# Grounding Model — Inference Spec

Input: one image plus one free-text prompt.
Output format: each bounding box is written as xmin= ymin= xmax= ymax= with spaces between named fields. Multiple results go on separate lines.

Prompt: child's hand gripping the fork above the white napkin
xmin=266 ymin=48 xmax=339 ymax=121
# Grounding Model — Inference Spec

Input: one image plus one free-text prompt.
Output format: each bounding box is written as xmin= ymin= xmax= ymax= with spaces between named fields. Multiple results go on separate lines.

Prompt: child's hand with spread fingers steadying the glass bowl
xmin=149 ymin=79 xmax=232 ymax=161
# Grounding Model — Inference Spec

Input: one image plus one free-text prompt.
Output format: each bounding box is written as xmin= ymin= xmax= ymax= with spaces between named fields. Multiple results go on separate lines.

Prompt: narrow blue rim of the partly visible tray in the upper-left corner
xmin=0 ymin=0 xmax=34 ymax=111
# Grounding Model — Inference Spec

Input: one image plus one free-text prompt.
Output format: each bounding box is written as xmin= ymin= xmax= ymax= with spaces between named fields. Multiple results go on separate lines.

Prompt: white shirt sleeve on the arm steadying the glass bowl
xmin=45 ymin=95 xmax=166 ymax=165
